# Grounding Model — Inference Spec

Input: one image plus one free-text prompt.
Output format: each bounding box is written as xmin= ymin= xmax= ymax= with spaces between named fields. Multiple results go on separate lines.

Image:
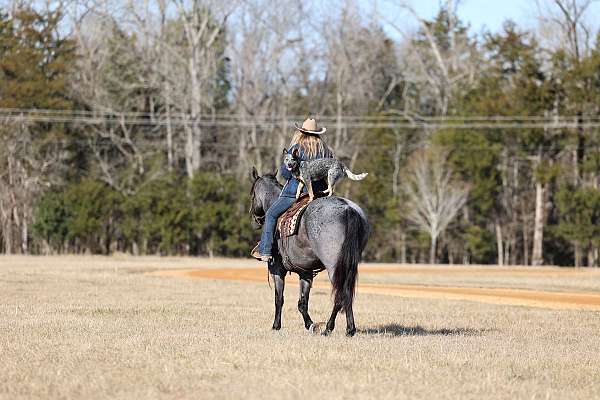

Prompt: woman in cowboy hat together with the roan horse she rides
xmin=250 ymin=119 xmax=370 ymax=336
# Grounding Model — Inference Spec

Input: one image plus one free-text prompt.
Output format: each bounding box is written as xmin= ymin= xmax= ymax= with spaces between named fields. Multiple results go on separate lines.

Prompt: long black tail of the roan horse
xmin=333 ymin=207 xmax=368 ymax=312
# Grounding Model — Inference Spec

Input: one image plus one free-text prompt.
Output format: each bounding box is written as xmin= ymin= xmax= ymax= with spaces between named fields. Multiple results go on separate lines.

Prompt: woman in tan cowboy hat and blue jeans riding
xmin=251 ymin=118 xmax=333 ymax=262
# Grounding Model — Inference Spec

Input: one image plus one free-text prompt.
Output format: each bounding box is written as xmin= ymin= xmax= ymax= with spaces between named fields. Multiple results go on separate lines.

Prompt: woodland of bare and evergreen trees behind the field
xmin=0 ymin=0 xmax=600 ymax=266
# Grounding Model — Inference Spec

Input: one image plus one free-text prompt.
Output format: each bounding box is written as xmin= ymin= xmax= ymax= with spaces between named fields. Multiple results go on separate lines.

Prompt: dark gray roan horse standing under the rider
xmin=250 ymin=168 xmax=370 ymax=336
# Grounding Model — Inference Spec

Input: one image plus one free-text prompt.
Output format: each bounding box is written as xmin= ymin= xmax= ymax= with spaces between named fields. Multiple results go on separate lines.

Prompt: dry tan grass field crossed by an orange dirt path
xmin=0 ymin=256 xmax=600 ymax=399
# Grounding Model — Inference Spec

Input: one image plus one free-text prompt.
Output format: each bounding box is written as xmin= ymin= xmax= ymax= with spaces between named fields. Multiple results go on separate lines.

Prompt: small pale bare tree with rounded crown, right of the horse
xmin=404 ymin=148 xmax=469 ymax=264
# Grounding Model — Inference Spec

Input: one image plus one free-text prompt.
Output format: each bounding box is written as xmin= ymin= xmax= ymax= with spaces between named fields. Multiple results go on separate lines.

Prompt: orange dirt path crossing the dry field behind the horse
xmin=148 ymin=267 xmax=600 ymax=311
